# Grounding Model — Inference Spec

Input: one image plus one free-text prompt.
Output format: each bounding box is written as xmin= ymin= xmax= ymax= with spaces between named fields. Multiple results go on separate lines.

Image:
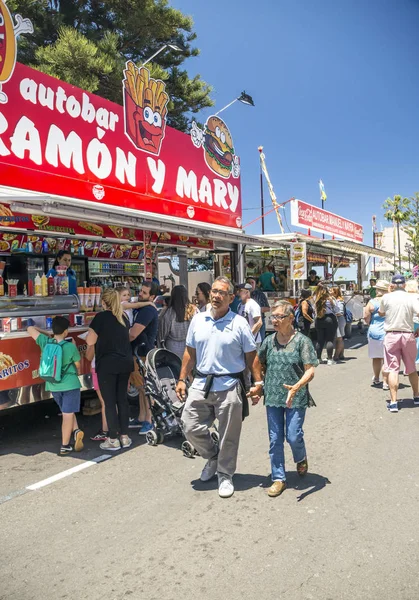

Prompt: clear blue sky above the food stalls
xmin=171 ymin=0 xmax=419 ymax=244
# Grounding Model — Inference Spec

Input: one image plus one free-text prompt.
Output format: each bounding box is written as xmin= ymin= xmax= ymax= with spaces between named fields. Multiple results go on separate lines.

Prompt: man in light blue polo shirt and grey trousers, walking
xmin=176 ymin=277 xmax=263 ymax=498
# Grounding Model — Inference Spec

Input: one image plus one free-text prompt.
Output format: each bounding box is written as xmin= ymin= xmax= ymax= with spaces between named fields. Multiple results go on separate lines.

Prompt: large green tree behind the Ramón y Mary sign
xmin=8 ymin=0 xmax=214 ymax=131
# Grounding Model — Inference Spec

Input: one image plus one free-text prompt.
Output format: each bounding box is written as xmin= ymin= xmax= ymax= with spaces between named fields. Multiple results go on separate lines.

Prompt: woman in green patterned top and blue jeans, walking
xmin=259 ymin=300 xmax=319 ymax=497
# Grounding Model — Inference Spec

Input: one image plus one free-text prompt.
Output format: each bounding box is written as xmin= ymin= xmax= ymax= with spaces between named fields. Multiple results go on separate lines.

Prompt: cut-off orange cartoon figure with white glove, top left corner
xmin=0 ymin=0 xmax=33 ymax=104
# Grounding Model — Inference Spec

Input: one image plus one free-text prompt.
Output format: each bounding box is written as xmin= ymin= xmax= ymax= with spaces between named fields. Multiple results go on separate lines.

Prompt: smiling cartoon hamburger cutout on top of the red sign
xmin=191 ymin=115 xmax=240 ymax=179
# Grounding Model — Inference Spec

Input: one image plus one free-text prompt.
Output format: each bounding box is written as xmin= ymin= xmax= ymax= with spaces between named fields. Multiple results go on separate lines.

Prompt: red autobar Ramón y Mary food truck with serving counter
xmin=0 ymin=9 xmax=288 ymax=410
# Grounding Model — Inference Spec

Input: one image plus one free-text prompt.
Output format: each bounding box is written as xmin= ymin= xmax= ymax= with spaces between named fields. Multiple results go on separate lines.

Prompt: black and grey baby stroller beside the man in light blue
xmin=144 ymin=348 xmax=218 ymax=458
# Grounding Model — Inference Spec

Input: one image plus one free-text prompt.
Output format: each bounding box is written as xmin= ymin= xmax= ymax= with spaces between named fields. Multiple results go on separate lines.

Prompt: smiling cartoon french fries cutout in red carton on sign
xmin=124 ymin=61 xmax=169 ymax=154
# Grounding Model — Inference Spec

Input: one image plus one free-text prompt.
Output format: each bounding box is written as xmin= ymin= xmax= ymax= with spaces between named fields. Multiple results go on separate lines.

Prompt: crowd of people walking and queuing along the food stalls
xmin=28 ymin=275 xmax=419 ymax=498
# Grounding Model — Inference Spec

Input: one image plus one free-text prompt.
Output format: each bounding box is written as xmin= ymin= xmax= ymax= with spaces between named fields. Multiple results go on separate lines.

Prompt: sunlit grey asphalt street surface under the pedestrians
xmin=0 ymin=337 xmax=419 ymax=600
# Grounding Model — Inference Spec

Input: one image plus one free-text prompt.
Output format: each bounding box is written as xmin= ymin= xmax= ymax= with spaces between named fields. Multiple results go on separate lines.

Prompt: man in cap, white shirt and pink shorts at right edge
xmin=379 ymin=275 xmax=419 ymax=412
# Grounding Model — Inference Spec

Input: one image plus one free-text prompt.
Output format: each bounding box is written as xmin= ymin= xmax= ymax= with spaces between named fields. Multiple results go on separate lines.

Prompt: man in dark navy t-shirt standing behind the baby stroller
xmin=129 ymin=281 xmax=159 ymax=435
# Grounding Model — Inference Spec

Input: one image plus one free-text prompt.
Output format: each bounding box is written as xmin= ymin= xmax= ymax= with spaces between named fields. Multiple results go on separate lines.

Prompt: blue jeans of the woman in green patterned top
xmin=266 ymin=406 xmax=306 ymax=481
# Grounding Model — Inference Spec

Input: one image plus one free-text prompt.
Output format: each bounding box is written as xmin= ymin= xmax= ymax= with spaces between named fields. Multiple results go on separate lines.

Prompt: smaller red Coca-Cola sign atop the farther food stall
xmin=291 ymin=200 xmax=364 ymax=243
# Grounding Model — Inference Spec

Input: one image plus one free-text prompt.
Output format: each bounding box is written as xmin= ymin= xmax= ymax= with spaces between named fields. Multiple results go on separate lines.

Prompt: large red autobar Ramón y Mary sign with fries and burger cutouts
xmin=0 ymin=62 xmax=242 ymax=229
